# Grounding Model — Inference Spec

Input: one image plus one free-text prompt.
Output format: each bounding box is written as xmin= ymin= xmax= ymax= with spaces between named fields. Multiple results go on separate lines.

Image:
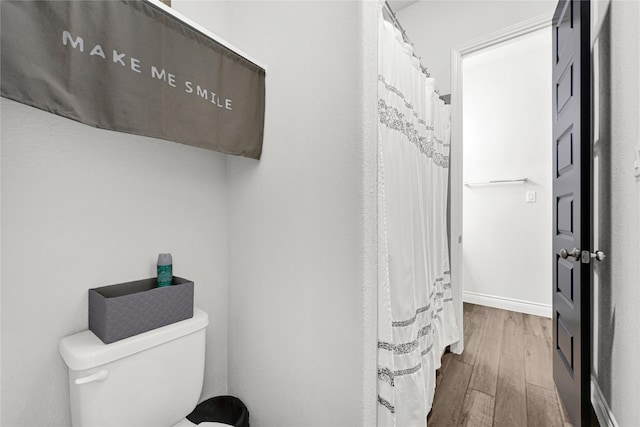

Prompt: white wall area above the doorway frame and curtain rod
xmin=398 ymin=0 xmax=556 ymax=94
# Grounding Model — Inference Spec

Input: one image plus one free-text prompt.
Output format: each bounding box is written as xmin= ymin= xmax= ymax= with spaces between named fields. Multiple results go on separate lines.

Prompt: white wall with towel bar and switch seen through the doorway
xmin=462 ymin=28 xmax=551 ymax=316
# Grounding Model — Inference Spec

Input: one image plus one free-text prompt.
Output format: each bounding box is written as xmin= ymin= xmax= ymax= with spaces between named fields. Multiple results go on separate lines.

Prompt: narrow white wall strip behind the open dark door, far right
xmin=592 ymin=1 xmax=640 ymax=426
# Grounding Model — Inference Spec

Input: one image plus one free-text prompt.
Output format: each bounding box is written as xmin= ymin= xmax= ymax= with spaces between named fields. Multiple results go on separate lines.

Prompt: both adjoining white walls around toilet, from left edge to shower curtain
xmin=1 ymin=0 xmax=377 ymax=427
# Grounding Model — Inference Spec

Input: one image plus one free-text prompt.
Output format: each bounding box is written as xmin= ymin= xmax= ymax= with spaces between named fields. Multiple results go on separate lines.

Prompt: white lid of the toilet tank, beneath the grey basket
xmin=60 ymin=307 xmax=209 ymax=371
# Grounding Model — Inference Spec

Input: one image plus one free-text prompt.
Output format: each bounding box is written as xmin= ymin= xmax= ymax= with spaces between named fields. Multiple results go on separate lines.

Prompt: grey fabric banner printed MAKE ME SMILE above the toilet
xmin=0 ymin=0 xmax=265 ymax=159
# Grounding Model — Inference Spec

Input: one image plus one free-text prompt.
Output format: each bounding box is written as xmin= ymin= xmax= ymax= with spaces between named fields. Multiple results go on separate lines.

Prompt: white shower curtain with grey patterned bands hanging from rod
xmin=378 ymin=7 xmax=459 ymax=427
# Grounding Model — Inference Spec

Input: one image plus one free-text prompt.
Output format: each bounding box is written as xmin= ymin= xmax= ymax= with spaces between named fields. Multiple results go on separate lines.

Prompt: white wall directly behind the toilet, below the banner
xmin=0 ymin=98 xmax=228 ymax=427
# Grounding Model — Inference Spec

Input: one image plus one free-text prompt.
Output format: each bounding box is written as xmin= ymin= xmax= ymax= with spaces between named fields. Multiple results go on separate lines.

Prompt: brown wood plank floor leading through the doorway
xmin=427 ymin=303 xmax=572 ymax=427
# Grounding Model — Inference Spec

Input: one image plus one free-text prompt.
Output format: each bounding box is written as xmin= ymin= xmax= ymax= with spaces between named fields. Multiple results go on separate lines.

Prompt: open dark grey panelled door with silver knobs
xmin=553 ymin=0 xmax=592 ymax=426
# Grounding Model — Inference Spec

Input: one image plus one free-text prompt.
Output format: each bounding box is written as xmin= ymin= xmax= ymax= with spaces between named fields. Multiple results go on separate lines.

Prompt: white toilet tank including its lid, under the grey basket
xmin=60 ymin=307 xmax=209 ymax=427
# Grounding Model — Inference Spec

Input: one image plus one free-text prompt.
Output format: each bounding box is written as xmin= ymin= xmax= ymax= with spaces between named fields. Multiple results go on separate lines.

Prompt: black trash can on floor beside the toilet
xmin=187 ymin=396 xmax=249 ymax=427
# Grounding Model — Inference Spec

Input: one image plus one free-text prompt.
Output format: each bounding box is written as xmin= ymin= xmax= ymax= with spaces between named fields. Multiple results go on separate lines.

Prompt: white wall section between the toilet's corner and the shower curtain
xmin=174 ymin=1 xmax=377 ymax=427
